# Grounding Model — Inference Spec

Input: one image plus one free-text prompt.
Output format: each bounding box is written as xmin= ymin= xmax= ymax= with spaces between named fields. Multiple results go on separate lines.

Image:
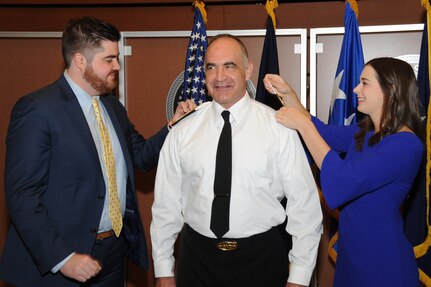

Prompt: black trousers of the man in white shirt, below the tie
xmin=177 ymin=224 xmax=289 ymax=287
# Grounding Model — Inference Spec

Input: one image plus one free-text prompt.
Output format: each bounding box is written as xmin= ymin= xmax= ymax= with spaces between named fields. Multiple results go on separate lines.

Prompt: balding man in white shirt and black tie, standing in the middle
xmin=151 ymin=34 xmax=322 ymax=287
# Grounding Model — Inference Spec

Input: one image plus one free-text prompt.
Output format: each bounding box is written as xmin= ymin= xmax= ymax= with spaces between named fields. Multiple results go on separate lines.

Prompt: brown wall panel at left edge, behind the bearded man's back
xmin=0 ymin=38 xmax=64 ymax=286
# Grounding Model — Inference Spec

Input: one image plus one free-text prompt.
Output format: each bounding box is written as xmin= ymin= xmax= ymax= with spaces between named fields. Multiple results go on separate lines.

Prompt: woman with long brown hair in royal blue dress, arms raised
xmin=264 ymin=58 xmax=424 ymax=287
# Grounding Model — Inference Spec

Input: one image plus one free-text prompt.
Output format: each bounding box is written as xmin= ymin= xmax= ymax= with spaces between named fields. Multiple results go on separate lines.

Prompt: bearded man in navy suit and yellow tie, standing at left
xmin=0 ymin=17 xmax=194 ymax=287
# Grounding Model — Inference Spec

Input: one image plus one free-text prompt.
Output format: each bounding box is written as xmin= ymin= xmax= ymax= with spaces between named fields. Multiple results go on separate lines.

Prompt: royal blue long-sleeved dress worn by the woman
xmin=312 ymin=118 xmax=424 ymax=287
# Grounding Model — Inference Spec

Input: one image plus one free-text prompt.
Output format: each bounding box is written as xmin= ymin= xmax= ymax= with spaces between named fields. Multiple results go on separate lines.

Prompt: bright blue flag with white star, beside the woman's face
xmin=329 ymin=0 xmax=364 ymax=125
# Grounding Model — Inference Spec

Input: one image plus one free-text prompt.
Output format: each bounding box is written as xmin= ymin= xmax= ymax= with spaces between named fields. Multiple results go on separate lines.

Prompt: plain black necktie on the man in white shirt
xmin=210 ymin=111 xmax=232 ymax=238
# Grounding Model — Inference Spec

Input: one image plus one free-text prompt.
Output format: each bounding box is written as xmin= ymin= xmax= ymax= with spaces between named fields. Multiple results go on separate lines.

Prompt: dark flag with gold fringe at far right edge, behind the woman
xmin=404 ymin=0 xmax=431 ymax=287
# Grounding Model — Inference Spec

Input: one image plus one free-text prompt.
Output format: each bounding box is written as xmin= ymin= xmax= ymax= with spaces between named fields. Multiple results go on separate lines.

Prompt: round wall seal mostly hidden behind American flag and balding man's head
xmin=166 ymin=71 xmax=256 ymax=121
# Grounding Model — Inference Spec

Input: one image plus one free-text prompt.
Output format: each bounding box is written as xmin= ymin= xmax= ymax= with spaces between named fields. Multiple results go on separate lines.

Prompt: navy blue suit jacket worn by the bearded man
xmin=0 ymin=75 xmax=168 ymax=287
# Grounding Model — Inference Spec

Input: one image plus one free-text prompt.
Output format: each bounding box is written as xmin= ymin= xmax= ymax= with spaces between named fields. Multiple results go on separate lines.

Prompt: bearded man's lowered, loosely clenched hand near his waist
xmin=60 ymin=253 xmax=102 ymax=282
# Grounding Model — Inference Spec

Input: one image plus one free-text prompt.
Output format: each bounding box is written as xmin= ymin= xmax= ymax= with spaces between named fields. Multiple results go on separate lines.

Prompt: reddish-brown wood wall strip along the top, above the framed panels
xmin=0 ymin=0 xmax=424 ymax=31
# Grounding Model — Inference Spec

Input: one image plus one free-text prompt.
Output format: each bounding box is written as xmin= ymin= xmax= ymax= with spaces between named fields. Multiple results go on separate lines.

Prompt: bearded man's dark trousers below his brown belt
xmin=82 ymin=233 xmax=125 ymax=287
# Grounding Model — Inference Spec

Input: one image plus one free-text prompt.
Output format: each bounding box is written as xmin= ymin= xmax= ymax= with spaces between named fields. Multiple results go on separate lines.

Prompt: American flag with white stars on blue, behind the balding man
xmin=180 ymin=1 xmax=208 ymax=105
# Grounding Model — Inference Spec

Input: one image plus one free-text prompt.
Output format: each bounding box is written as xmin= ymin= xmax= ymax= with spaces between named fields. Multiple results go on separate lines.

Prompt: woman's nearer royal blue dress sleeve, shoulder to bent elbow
xmin=320 ymin=133 xmax=423 ymax=208
